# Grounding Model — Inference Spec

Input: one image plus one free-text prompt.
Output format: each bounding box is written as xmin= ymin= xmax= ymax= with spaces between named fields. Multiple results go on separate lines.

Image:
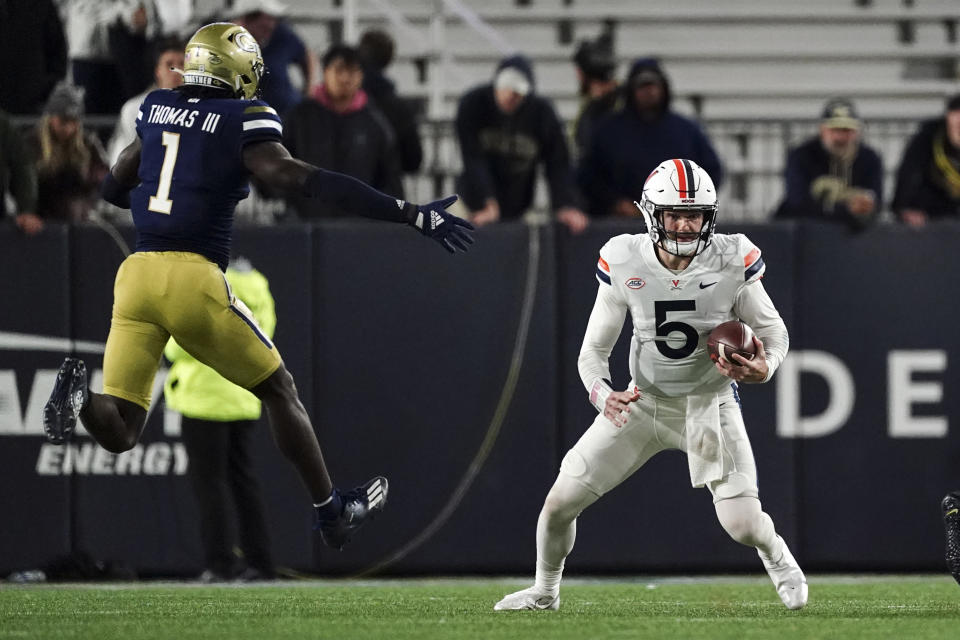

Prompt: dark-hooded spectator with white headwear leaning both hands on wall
xmin=456 ymin=56 xmax=588 ymax=233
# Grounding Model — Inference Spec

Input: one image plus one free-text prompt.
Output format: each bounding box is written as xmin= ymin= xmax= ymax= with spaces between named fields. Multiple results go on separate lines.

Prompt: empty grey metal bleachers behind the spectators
xmin=204 ymin=0 xmax=960 ymax=220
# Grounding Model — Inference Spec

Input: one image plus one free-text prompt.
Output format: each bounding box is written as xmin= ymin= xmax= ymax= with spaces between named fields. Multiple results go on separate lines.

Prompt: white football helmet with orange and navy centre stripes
xmin=634 ymin=158 xmax=717 ymax=256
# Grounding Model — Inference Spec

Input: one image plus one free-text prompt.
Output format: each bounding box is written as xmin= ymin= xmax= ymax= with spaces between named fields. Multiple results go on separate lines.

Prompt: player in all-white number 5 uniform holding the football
xmin=494 ymin=159 xmax=807 ymax=610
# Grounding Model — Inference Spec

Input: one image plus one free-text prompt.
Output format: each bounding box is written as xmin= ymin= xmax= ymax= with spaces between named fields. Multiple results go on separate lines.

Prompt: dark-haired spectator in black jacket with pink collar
xmin=283 ymin=44 xmax=403 ymax=218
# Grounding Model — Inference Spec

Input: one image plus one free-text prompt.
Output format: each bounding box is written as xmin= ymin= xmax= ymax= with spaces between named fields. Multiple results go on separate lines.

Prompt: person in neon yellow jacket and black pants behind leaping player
xmin=163 ymin=258 xmax=277 ymax=582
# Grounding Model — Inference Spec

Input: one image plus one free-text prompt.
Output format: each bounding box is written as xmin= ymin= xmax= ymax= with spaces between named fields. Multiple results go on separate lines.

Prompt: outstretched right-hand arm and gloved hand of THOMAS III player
xmin=243 ymin=141 xmax=473 ymax=253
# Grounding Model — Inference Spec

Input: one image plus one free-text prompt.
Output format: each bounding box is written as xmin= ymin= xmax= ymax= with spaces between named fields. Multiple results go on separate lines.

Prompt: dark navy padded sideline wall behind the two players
xmin=0 ymin=221 xmax=960 ymax=575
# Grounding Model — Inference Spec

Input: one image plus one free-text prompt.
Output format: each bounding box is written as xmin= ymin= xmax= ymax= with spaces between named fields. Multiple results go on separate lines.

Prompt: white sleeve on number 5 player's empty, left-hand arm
xmin=577 ymin=282 xmax=627 ymax=396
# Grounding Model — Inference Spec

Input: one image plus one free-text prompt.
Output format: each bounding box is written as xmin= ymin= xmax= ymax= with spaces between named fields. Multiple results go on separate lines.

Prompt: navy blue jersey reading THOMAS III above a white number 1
xmin=130 ymin=89 xmax=283 ymax=269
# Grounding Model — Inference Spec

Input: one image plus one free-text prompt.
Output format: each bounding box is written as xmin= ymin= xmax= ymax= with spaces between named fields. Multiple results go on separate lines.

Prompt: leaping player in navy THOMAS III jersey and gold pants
xmin=43 ymin=23 xmax=473 ymax=548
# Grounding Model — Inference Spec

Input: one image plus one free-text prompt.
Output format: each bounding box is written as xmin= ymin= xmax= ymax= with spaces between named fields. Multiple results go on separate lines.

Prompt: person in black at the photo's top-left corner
xmin=0 ymin=0 xmax=67 ymax=115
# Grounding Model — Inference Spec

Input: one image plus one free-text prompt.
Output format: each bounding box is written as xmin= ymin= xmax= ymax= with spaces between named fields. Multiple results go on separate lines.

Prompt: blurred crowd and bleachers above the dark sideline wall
xmin=0 ymin=0 xmax=960 ymax=234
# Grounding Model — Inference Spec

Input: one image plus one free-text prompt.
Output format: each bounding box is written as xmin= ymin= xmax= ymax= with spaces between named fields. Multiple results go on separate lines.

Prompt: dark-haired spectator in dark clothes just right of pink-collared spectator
xmin=357 ymin=29 xmax=423 ymax=173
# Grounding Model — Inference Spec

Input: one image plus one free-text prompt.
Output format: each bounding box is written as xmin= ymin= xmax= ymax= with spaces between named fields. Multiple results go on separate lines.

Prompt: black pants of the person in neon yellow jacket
xmin=181 ymin=416 xmax=274 ymax=578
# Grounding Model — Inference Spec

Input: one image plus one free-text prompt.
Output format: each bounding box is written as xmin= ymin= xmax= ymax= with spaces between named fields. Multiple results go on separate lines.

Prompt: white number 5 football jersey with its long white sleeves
xmin=579 ymin=234 xmax=788 ymax=397
